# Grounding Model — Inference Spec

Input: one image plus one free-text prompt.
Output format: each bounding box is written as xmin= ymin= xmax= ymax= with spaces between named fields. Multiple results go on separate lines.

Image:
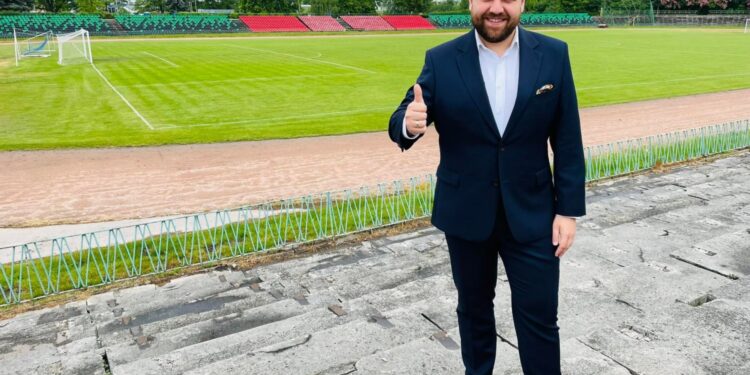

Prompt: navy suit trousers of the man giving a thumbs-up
xmin=445 ymin=201 xmax=560 ymax=375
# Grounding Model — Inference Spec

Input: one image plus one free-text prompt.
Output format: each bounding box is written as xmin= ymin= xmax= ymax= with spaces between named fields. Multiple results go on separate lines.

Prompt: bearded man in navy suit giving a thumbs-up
xmin=389 ymin=0 xmax=586 ymax=375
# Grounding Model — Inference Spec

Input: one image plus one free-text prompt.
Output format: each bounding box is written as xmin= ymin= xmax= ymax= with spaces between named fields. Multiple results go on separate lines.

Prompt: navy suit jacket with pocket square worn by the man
xmin=389 ymin=27 xmax=586 ymax=242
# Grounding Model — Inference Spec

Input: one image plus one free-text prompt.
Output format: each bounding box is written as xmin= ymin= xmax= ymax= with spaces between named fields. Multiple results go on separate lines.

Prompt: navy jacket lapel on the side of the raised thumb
xmin=456 ymin=29 xmax=500 ymax=138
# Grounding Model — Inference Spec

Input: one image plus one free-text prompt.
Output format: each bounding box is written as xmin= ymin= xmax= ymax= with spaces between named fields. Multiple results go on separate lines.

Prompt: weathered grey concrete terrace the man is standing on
xmin=0 ymin=152 xmax=750 ymax=375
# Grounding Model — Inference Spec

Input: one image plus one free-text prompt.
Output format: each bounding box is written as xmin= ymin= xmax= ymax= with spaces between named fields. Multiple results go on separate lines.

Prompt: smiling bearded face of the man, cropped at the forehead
xmin=469 ymin=0 xmax=525 ymax=43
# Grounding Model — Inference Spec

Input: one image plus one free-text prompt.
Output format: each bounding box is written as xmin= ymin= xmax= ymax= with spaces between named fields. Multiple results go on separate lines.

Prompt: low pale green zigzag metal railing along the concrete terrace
xmin=0 ymin=120 xmax=750 ymax=305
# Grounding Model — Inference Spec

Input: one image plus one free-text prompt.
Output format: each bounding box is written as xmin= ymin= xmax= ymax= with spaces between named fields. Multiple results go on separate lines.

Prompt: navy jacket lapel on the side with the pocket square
xmin=503 ymin=27 xmax=542 ymax=138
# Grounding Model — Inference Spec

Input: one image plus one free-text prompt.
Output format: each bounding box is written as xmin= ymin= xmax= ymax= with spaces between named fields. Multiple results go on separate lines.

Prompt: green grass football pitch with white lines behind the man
xmin=0 ymin=29 xmax=750 ymax=150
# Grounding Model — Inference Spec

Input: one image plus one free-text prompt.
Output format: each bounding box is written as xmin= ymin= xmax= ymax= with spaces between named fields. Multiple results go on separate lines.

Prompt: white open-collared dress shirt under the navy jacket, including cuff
xmin=403 ymin=26 xmax=521 ymax=139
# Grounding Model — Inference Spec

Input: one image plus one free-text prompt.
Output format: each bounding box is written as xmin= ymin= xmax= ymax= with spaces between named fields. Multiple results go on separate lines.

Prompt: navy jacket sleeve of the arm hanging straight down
xmin=550 ymin=44 xmax=586 ymax=216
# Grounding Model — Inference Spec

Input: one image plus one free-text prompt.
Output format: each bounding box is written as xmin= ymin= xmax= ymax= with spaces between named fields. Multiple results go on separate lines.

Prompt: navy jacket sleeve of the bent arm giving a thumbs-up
xmin=388 ymin=51 xmax=435 ymax=151
